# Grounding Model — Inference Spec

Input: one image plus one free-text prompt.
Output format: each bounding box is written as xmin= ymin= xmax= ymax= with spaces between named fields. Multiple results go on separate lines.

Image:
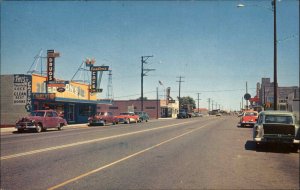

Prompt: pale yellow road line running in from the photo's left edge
xmin=1 ymin=121 xmax=202 ymax=160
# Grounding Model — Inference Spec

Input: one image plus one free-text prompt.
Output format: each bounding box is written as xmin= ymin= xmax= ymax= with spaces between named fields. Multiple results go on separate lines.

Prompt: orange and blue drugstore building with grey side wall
xmin=1 ymin=74 xmax=97 ymax=127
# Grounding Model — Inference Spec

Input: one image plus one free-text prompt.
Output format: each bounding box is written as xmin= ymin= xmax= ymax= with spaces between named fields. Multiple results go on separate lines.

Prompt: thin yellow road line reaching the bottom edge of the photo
xmin=48 ymin=123 xmax=209 ymax=190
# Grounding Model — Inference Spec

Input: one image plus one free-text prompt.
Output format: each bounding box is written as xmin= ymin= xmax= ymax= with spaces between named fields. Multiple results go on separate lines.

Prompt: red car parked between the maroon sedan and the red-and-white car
xmin=88 ymin=112 xmax=119 ymax=126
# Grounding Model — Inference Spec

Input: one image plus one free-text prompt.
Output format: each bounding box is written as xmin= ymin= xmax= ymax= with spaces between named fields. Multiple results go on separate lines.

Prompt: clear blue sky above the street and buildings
xmin=1 ymin=0 xmax=299 ymax=110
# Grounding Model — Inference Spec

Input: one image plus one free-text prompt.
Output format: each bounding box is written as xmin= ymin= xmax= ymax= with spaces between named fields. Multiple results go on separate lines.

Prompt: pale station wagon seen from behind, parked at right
xmin=253 ymin=111 xmax=300 ymax=151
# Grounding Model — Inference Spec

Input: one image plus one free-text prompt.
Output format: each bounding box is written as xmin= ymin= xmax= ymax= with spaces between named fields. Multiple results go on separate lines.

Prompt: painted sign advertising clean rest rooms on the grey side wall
xmin=13 ymin=74 xmax=32 ymax=111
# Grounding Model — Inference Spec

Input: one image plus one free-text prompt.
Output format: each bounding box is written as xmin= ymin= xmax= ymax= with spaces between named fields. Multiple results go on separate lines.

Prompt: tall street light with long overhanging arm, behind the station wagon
xmin=237 ymin=0 xmax=278 ymax=110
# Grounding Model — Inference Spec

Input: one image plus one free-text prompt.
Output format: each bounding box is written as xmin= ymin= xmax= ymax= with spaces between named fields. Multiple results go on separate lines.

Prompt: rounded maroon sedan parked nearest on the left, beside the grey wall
xmin=16 ymin=110 xmax=67 ymax=133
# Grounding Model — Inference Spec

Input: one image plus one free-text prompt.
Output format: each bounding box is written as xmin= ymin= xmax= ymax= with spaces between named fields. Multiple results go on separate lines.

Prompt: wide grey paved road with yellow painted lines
xmin=1 ymin=116 xmax=299 ymax=189
